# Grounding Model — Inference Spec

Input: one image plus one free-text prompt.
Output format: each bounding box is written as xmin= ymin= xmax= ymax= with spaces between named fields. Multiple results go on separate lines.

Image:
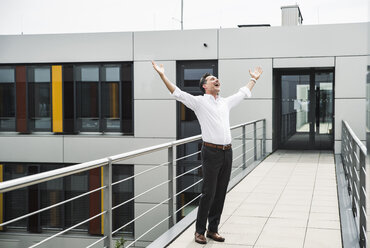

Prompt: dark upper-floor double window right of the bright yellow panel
xmin=75 ymin=64 xmax=133 ymax=134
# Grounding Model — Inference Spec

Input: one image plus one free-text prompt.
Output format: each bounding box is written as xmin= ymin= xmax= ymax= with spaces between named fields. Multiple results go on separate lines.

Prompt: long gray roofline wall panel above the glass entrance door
xmin=219 ymin=23 xmax=368 ymax=59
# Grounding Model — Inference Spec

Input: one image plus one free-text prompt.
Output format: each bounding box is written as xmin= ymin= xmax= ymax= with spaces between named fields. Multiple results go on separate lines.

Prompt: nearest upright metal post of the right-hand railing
xmin=358 ymin=150 xmax=367 ymax=248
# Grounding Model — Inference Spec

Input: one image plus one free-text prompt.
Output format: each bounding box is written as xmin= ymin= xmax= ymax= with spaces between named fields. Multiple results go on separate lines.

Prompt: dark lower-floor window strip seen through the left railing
xmin=0 ymin=163 xmax=134 ymax=234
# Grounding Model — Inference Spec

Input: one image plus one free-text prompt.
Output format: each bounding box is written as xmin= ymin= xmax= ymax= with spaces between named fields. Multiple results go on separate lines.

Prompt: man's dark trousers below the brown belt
xmin=195 ymin=146 xmax=233 ymax=234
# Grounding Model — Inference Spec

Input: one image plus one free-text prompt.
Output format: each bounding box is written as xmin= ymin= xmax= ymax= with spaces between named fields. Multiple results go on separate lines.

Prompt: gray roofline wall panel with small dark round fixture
xmin=134 ymin=29 xmax=218 ymax=60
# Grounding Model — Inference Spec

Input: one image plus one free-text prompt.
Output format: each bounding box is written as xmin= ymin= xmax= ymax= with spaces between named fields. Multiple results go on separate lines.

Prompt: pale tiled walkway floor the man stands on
xmin=169 ymin=150 xmax=342 ymax=248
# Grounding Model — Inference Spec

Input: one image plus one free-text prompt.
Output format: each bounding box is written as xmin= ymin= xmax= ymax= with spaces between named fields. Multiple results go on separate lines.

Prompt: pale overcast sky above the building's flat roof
xmin=0 ymin=0 xmax=369 ymax=35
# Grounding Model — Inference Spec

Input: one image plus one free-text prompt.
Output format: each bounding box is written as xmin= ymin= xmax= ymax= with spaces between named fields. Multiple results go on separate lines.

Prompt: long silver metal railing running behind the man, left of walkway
xmin=0 ymin=119 xmax=266 ymax=247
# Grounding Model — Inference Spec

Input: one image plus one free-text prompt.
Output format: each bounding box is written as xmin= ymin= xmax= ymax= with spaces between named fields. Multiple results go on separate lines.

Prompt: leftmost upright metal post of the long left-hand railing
xmin=103 ymin=158 xmax=113 ymax=248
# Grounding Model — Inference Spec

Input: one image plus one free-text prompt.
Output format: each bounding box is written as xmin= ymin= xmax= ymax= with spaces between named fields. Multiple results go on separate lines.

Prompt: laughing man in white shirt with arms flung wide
xmin=152 ymin=61 xmax=262 ymax=244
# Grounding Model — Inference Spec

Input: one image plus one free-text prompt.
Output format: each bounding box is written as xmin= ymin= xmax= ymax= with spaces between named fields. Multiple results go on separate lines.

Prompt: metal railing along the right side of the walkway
xmin=341 ymin=121 xmax=367 ymax=247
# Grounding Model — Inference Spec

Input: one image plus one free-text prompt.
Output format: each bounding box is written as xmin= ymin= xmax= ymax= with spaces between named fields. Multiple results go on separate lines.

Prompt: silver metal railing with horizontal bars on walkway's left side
xmin=0 ymin=119 xmax=266 ymax=247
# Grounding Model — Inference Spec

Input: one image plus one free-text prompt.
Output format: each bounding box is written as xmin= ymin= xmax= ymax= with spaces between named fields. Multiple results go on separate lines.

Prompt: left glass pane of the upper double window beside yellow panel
xmin=76 ymin=66 xmax=100 ymax=132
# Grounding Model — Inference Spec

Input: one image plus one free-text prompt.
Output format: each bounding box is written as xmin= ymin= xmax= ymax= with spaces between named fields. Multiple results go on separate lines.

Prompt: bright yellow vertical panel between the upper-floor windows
xmin=52 ymin=65 xmax=63 ymax=133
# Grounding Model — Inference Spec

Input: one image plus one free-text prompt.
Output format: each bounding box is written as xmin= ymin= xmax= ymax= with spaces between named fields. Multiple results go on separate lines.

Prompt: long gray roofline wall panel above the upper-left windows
xmin=0 ymin=32 xmax=133 ymax=63
